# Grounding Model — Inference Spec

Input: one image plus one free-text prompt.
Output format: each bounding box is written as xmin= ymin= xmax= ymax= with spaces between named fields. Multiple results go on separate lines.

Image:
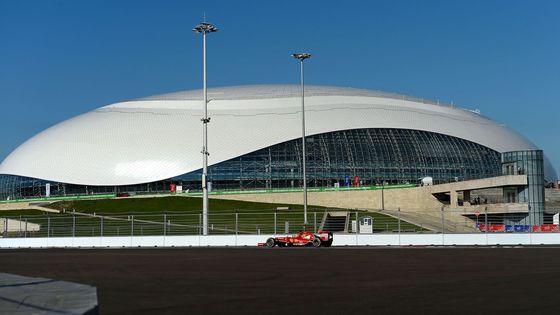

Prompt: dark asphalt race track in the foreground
xmin=0 ymin=247 xmax=560 ymax=315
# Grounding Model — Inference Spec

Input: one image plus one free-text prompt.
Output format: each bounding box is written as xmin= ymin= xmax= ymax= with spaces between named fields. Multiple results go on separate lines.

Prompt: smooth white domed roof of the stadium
xmin=0 ymin=85 xmax=556 ymax=186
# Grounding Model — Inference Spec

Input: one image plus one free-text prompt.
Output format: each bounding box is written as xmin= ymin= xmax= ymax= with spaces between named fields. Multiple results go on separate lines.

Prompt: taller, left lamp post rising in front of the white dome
xmin=193 ymin=23 xmax=218 ymax=235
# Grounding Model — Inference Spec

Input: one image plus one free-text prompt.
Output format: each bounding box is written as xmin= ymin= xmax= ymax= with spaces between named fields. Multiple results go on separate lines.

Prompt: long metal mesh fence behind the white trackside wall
xmin=0 ymin=209 xmax=559 ymax=237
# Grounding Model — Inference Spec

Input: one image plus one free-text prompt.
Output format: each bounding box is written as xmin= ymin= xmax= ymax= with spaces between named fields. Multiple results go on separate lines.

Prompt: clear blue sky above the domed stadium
xmin=0 ymin=0 xmax=560 ymax=177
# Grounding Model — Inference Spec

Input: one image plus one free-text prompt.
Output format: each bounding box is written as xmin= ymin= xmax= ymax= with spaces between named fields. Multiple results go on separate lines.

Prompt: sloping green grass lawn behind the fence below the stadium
xmin=3 ymin=197 xmax=422 ymax=237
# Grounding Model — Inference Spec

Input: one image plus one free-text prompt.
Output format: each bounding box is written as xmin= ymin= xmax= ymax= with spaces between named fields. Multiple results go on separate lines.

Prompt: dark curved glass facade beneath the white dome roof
xmin=0 ymin=128 xmax=502 ymax=199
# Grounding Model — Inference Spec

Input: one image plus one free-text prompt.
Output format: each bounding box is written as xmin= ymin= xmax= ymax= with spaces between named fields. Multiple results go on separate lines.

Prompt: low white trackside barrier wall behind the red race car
xmin=0 ymin=233 xmax=560 ymax=249
